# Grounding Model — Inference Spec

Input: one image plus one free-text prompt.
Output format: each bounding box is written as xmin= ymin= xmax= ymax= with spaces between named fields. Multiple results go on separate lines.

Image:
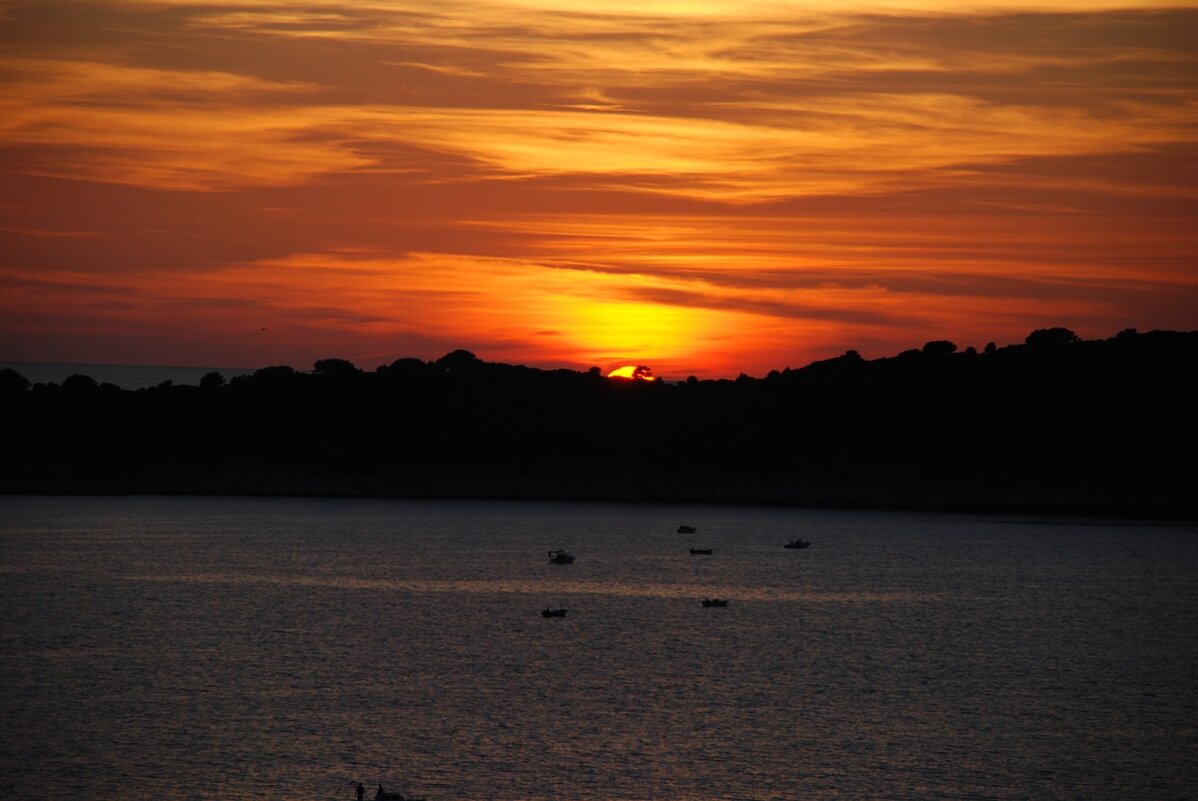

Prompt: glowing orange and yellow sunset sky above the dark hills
xmin=0 ymin=0 xmax=1198 ymax=378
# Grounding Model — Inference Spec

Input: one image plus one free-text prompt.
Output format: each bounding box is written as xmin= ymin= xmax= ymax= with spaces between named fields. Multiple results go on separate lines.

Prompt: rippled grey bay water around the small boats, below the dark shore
xmin=0 ymin=497 xmax=1198 ymax=801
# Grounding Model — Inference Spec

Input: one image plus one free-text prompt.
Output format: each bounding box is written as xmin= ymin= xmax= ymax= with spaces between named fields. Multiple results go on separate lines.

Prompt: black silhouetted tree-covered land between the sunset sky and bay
xmin=0 ymin=328 xmax=1198 ymax=515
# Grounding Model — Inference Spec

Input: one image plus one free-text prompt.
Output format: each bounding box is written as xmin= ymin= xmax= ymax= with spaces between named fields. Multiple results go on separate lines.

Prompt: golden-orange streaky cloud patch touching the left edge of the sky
xmin=0 ymin=57 xmax=365 ymax=189
